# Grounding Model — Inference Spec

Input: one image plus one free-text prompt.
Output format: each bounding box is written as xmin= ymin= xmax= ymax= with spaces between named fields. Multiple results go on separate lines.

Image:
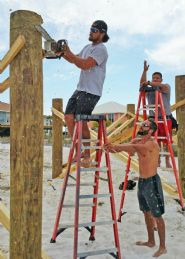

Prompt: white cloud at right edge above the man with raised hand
xmin=146 ymin=36 xmax=185 ymax=72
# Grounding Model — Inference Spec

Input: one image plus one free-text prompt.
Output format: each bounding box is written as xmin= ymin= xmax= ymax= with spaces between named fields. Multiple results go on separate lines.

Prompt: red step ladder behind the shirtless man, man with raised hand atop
xmin=118 ymin=86 xmax=185 ymax=222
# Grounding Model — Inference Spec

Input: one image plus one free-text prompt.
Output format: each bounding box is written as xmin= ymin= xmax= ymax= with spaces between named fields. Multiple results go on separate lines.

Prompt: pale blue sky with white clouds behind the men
xmin=0 ymin=0 xmax=185 ymax=115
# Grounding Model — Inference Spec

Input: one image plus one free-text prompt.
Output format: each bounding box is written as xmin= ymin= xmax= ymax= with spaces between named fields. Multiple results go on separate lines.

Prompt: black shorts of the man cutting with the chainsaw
xmin=65 ymin=90 xmax=100 ymax=115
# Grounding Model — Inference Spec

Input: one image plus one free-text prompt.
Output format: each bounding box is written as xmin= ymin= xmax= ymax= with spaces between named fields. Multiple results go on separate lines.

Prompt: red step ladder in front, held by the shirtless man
xmin=51 ymin=115 xmax=121 ymax=259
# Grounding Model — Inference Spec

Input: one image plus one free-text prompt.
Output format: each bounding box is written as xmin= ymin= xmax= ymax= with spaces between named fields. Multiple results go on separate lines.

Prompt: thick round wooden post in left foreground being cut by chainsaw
xmin=10 ymin=10 xmax=43 ymax=259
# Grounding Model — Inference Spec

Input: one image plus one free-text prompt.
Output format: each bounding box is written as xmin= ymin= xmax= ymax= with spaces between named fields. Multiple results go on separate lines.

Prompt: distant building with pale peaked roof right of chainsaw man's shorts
xmin=93 ymin=102 xmax=127 ymax=122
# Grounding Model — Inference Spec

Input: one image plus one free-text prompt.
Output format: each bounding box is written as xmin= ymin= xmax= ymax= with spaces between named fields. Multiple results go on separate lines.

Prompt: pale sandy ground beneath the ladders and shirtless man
xmin=0 ymin=143 xmax=185 ymax=259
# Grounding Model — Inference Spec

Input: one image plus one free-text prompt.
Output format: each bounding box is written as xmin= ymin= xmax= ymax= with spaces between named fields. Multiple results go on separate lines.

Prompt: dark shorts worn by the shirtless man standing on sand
xmin=138 ymin=174 xmax=164 ymax=217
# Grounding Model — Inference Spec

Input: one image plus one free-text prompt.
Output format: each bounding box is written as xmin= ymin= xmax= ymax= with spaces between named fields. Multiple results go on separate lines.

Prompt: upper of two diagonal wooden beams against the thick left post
xmin=0 ymin=35 xmax=26 ymax=74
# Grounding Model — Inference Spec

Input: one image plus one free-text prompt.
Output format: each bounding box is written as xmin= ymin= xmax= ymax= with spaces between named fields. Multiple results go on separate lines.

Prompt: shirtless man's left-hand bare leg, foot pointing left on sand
xmin=136 ymin=211 xmax=155 ymax=247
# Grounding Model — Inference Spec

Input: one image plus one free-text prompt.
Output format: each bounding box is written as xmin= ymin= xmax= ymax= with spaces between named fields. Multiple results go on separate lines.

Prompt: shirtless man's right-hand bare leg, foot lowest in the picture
xmin=153 ymin=216 xmax=167 ymax=257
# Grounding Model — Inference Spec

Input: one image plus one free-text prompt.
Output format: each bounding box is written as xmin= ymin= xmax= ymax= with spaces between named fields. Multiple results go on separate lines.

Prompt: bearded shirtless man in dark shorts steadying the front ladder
xmin=104 ymin=120 xmax=167 ymax=257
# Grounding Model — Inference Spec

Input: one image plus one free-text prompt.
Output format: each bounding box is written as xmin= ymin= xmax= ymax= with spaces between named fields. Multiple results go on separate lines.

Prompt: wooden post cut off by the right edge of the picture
xmin=175 ymin=75 xmax=185 ymax=198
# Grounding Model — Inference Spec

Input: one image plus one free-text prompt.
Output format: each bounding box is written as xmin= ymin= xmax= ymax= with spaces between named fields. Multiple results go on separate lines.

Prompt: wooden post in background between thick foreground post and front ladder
xmin=52 ymin=99 xmax=63 ymax=178
